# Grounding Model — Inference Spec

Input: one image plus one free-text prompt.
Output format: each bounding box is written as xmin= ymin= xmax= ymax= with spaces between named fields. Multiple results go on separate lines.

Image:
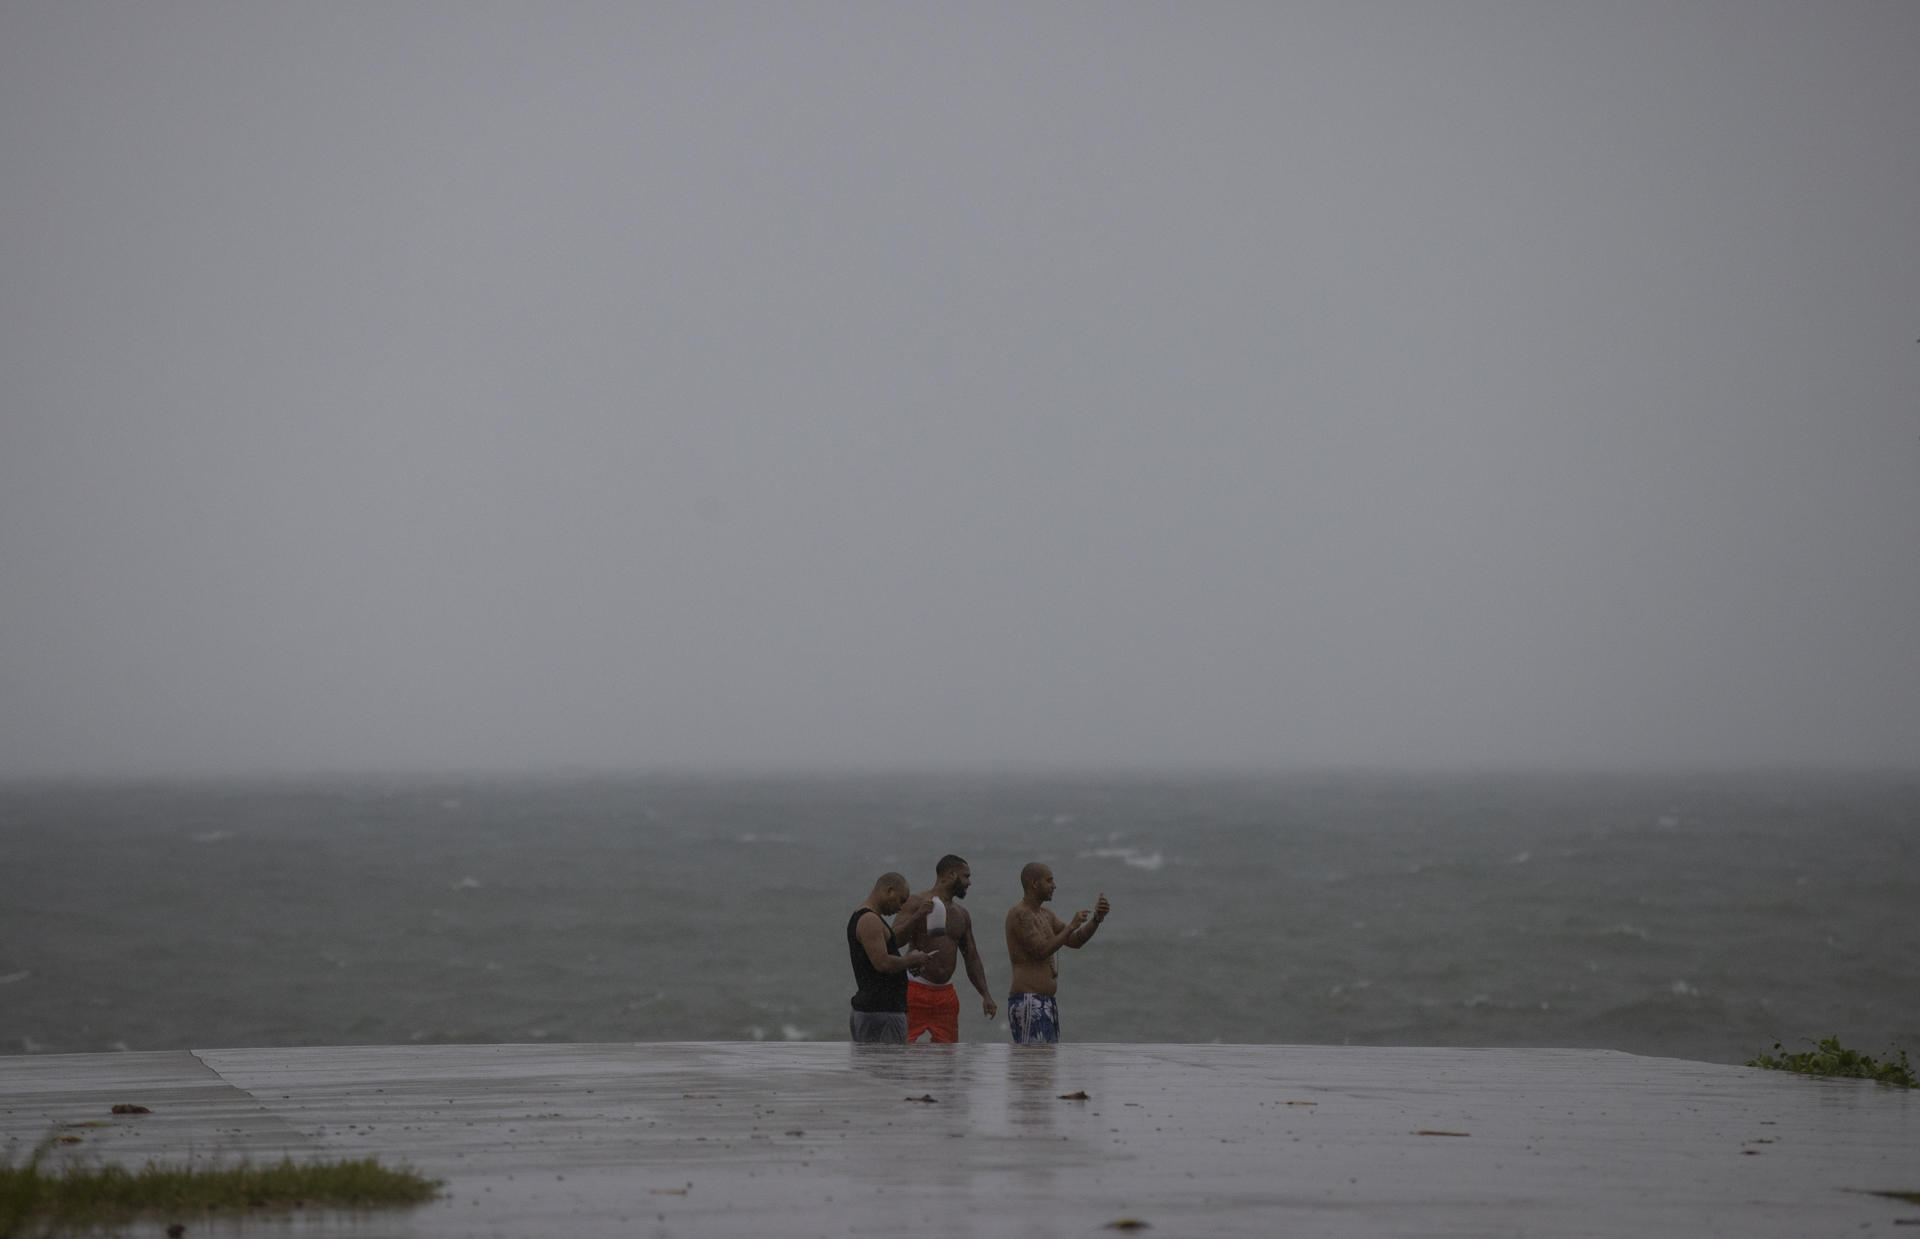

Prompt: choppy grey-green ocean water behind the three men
xmin=0 ymin=774 xmax=1920 ymax=1062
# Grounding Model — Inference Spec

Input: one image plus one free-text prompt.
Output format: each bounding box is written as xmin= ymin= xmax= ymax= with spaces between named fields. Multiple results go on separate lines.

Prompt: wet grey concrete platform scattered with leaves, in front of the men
xmin=0 ymin=1043 xmax=1920 ymax=1239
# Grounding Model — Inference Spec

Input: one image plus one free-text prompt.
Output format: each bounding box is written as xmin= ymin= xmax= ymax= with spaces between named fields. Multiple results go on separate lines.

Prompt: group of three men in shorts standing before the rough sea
xmin=847 ymin=855 xmax=1108 ymax=1045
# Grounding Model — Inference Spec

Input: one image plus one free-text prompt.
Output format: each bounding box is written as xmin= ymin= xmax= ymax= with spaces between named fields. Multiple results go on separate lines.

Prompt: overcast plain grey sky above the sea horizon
xmin=0 ymin=0 xmax=1920 ymax=772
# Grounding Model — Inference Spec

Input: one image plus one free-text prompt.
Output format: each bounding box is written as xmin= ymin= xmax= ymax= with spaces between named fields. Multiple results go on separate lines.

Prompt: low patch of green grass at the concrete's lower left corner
xmin=0 ymin=1151 xmax=440 ymax=1239
